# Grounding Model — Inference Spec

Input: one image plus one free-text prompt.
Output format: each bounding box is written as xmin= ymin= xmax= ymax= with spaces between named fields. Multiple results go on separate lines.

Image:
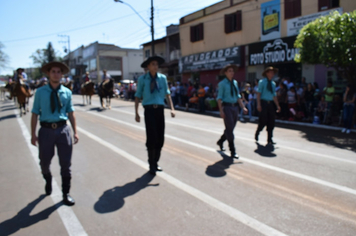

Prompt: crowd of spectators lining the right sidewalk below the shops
xmin=161 ymin=77 xmax=356 ymax=133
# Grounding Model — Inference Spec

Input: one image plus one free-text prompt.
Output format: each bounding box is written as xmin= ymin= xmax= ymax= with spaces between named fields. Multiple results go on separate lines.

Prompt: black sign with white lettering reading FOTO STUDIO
xmin=249 ymin=36 xmax=298 ymax=66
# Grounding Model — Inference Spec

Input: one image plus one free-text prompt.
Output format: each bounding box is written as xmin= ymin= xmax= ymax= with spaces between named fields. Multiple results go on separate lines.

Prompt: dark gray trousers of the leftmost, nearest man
xmin=38 ymin=125 xmax=73 ymax=177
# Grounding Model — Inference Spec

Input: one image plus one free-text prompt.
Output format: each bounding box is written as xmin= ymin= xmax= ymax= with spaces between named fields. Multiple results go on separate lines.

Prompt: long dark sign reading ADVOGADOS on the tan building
xmin=179 ymin=47 xmax=241 ymax=73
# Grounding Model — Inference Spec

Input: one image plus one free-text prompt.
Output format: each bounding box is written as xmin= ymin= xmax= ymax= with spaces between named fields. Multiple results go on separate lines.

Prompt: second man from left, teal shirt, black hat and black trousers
xmin=135 ymin=56 xmax=175 ymax=175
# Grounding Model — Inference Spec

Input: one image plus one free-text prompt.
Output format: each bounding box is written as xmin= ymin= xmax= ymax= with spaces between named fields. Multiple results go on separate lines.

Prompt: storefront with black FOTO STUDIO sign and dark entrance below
xmin=247 ymin=36 xmax=302 ymax=82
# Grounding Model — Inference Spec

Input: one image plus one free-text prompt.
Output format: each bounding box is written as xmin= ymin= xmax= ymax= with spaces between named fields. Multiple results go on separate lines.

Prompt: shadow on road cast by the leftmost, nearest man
xmin=0 ymin=194 xmax=63 ymax=235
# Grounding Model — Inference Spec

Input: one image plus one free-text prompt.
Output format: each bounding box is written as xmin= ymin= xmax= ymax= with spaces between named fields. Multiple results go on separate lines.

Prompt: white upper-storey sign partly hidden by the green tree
xmin=287 ymin=7 xmax=342 ymax=36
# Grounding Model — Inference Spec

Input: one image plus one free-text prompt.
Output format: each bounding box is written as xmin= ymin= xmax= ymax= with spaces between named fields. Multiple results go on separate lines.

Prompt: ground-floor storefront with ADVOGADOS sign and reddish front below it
xmin=179 ymin=46 xmax=245 ymax=86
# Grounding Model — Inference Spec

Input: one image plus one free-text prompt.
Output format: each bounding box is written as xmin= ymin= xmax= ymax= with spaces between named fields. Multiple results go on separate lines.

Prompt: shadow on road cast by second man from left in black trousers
xmin=94 ymin=172 xmax=159 ymax=214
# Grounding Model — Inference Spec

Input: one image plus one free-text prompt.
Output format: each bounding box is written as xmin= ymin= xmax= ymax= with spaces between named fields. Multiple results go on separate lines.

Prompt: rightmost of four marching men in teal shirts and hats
xmin=255 ymin=66 xmax=281 ymax=145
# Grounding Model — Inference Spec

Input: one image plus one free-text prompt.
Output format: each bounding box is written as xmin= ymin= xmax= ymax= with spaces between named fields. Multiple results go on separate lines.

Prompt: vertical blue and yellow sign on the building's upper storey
xmin=261 ymin=0 xmax=281 ymax=41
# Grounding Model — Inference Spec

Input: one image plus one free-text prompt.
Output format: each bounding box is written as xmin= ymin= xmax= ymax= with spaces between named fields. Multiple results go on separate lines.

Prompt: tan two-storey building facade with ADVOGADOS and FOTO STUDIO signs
xmin=179 ymin=0 xmax=356 ymax=87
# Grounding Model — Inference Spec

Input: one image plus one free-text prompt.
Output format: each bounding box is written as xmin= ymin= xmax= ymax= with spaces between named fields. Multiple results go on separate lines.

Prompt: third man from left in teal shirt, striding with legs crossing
xmin=216 ymin=64 xmax=247 ymax=158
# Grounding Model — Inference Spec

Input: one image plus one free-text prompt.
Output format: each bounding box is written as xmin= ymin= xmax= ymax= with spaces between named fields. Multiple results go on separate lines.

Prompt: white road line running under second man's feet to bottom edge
xmin=77 ymin=127 xmax=285 ymax=236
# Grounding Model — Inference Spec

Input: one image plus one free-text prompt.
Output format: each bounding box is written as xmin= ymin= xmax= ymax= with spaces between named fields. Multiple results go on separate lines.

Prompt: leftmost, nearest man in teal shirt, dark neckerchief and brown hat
xmin=31 ymin=62 xmax=79 ymax=206
